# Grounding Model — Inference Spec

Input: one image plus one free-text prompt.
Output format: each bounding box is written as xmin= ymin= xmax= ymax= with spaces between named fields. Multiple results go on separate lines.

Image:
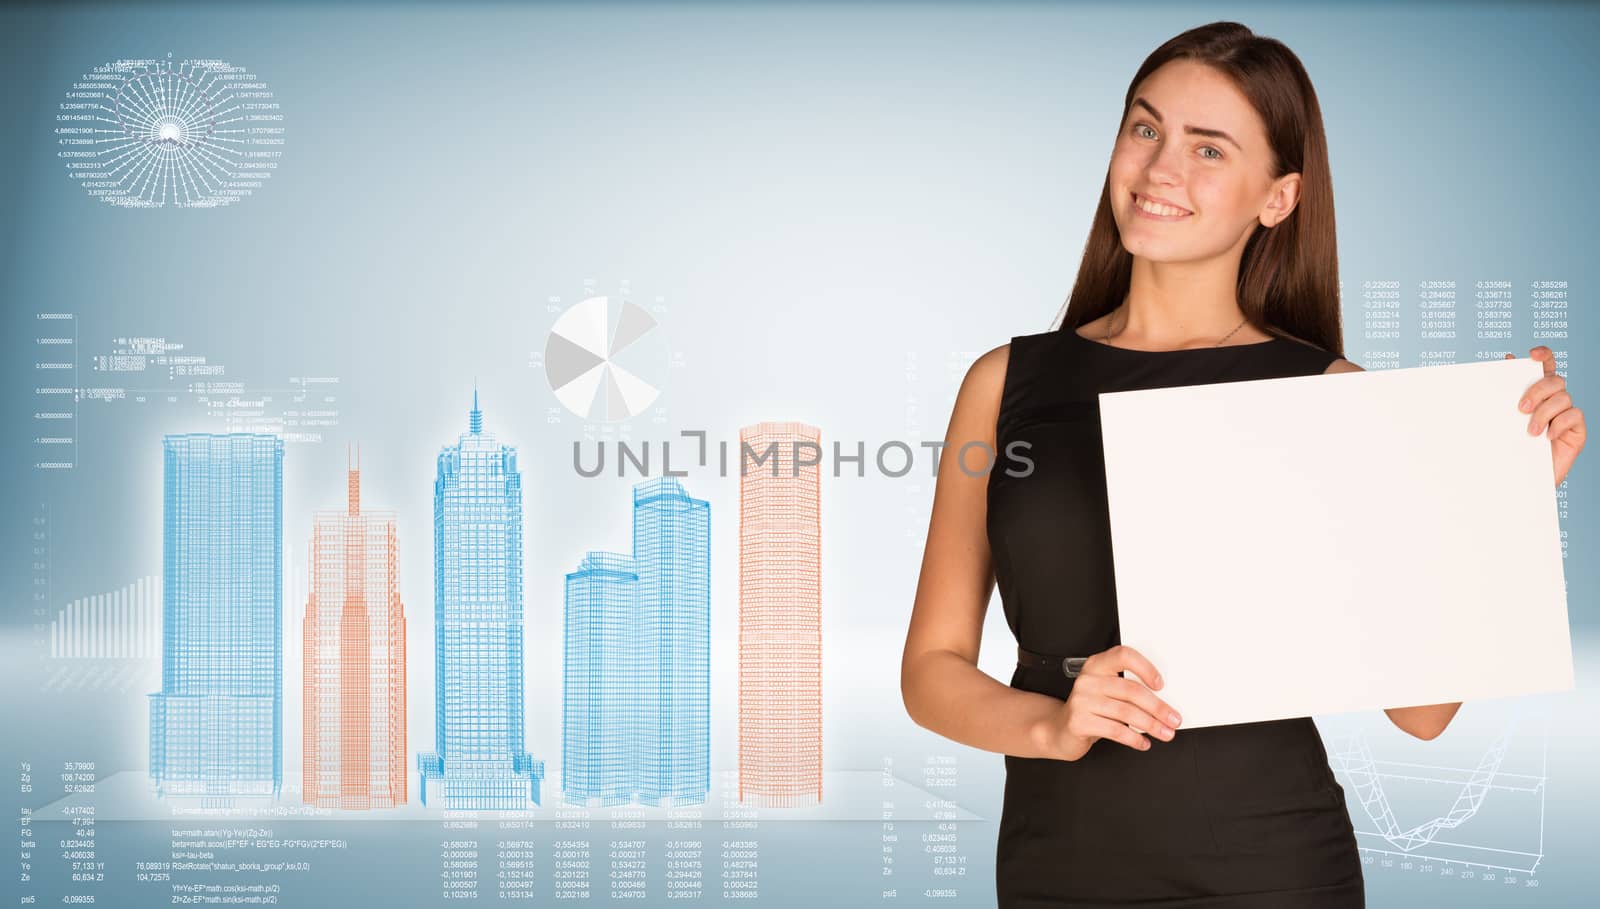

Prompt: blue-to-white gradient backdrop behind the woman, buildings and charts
xmin=0 ymin=3 xmax=1600 ymax=906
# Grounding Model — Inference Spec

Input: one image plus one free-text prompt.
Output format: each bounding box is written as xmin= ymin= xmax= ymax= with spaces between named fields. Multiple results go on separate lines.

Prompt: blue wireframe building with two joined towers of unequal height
xmin=562 ymin=477 xmax=710 ymax=805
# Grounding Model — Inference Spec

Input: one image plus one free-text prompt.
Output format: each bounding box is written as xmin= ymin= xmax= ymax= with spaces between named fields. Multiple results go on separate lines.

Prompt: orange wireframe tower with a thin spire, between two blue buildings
xmin=302 ymin=448 xmax=406 ymax=808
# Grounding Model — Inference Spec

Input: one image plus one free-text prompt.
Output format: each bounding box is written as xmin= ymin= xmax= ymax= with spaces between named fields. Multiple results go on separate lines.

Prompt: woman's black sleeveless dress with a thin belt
xmin=987 ymin=326 xmax=1365 ymax=909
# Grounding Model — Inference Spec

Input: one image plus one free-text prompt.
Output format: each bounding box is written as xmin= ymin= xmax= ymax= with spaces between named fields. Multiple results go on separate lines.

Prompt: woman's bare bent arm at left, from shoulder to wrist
xmin=901 ymin=344 xmax=1062 ymax=757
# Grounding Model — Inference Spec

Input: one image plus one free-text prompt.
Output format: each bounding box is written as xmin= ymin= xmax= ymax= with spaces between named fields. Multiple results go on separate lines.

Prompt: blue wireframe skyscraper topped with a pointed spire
xmin=418 ymin=390 xmax=544 ymax=810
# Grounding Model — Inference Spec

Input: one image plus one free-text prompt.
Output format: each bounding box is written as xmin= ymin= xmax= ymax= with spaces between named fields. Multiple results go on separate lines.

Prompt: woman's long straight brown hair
xmin=1058 ymin=22 xmax=1344 ymax=357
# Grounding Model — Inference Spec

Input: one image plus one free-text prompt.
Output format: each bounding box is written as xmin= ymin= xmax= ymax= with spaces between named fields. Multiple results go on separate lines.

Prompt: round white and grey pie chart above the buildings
xmin=544 ymin=296 xmax=667 ymax=422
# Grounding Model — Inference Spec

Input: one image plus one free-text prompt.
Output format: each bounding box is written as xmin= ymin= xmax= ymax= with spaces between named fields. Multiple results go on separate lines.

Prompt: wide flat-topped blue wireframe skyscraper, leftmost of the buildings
xmin=150 ymin=432 xmax=283 ymax=802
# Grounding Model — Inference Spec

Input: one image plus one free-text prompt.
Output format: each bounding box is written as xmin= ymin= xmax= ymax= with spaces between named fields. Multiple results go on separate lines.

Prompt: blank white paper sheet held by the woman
xmin=1099 ymin=357 xmax=1573 ymax=735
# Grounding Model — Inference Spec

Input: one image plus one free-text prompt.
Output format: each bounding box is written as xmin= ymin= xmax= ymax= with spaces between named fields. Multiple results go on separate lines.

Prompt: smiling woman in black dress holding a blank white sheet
xmin=901 ymin=22 xmax=1586 ymax=907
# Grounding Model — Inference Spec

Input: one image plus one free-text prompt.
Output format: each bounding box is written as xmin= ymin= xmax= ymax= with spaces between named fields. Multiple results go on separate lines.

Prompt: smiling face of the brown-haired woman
xmin=1109 ymin=61 xmax=1299 ymax=262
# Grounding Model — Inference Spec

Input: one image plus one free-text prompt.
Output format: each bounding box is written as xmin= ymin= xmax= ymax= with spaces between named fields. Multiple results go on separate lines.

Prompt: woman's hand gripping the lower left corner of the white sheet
xmin=1045 ymin=643 xmax=1182 ymax=760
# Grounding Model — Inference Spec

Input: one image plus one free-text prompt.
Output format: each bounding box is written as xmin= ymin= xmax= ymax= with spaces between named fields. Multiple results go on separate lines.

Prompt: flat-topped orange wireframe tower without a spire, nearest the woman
xmin=739 ymin=422 xmax=822 ymax=807
